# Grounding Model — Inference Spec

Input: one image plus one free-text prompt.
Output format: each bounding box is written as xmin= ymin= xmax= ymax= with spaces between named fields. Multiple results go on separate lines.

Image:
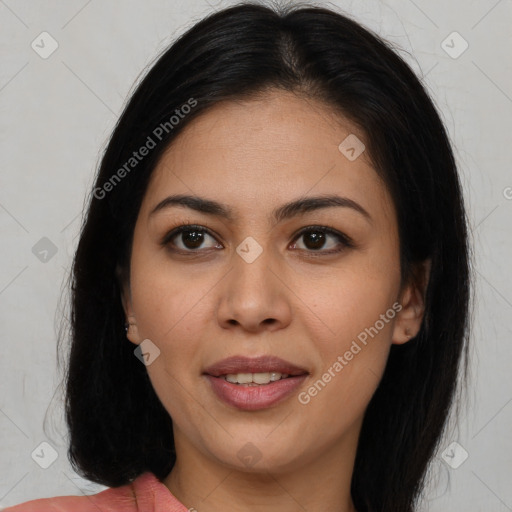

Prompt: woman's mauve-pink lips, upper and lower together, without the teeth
xmin=204 ymin=356 xmax=309 ymax=411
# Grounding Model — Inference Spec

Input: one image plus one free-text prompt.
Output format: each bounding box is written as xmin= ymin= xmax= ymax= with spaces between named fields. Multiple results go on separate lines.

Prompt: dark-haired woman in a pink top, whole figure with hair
xmin=7 ymin=4 xmax=469 ymax=512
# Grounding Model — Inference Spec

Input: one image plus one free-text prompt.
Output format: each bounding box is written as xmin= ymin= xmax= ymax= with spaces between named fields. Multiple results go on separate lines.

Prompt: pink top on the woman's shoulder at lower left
xmin=2 ymin=471 xmax=189 ymax=512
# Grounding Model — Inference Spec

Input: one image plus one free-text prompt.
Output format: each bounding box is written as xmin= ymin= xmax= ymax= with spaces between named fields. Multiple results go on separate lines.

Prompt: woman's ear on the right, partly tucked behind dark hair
xmin=392 ymin=260 xmax=431 ymax=345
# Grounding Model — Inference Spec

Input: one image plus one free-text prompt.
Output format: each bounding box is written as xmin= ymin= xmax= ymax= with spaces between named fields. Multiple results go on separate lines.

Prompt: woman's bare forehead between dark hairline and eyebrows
xmin=143 ymin=91 xmax=392 ymax=226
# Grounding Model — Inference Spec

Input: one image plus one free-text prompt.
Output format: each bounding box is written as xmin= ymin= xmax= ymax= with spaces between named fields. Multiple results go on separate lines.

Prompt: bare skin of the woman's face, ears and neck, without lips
xmin=123 ymin=90 xmax=428 ymax=512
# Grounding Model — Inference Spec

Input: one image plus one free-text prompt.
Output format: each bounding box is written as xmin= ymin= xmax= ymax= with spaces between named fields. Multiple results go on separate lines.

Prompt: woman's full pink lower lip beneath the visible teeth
xmin=205 ymin=374 xmax=307 ymax=411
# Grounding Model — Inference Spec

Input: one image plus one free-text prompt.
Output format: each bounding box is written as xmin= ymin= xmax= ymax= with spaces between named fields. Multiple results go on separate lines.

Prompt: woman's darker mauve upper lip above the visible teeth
xmin=204 ymin=355 xmax=308 ymax=377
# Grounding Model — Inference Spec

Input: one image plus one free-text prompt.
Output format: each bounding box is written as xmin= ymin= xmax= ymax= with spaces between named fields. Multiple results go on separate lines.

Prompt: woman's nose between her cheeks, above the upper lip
xmin=217 ymin=242 xmax=293 ymax=333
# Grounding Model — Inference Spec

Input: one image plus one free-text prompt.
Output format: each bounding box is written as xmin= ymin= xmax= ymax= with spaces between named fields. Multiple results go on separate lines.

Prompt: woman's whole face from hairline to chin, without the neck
xmin=123 ymin=91 xmax=421 ymax=472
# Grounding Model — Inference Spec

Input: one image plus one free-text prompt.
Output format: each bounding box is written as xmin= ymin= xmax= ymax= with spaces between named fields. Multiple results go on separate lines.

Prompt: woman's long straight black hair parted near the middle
xmin=59 ymin=3 xmax=470 ymax=512
